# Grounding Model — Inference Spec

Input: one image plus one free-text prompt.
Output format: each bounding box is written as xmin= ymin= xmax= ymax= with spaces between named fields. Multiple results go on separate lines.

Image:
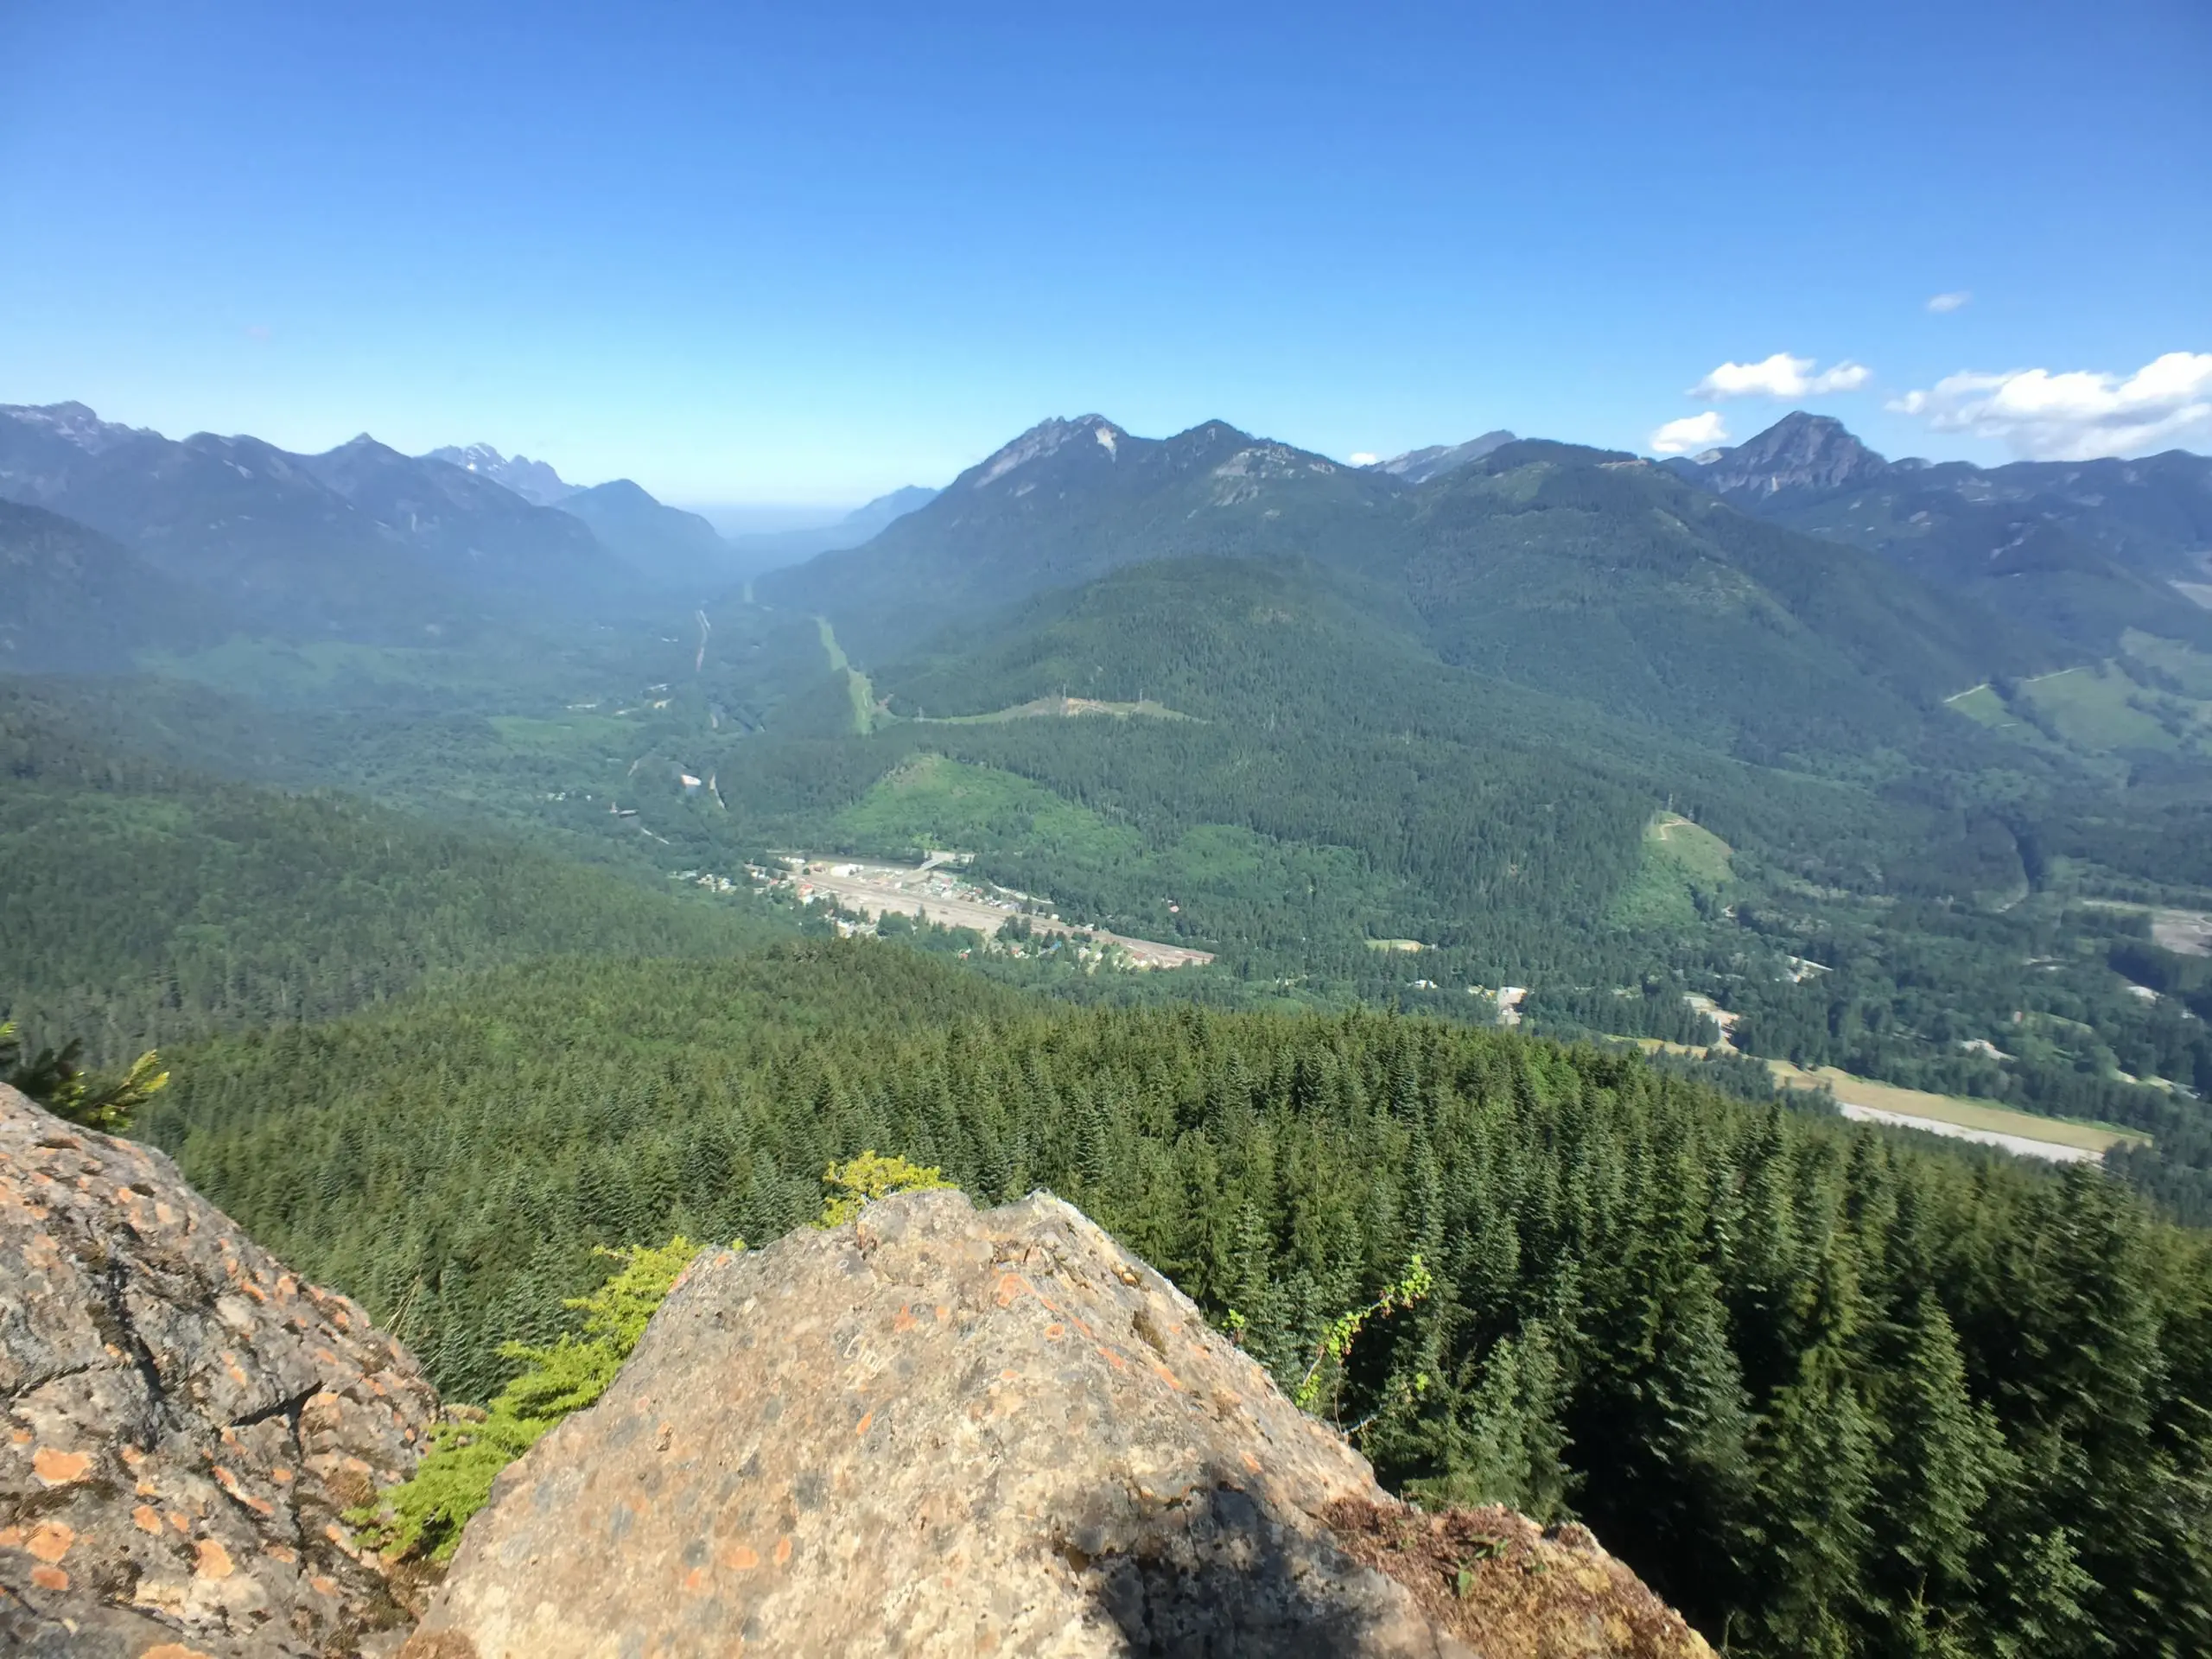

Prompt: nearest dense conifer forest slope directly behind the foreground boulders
xmin=150 ymin=944 xmax=2212 ymax=1659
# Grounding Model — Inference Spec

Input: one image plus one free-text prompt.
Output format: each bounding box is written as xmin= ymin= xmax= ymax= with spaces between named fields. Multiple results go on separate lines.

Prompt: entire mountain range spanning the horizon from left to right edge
xmin=0 ymin=393 xmax=2212 ymax=761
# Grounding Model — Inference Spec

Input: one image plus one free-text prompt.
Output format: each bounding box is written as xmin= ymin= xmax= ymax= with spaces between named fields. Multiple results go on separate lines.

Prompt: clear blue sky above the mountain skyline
xmin=0 ymin=0 xmax=2212 ymax=502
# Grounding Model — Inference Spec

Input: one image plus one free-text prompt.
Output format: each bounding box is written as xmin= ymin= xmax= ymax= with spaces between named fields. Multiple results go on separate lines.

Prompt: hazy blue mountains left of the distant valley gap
xmin=0 ymin=403 xmax=927 ymax=668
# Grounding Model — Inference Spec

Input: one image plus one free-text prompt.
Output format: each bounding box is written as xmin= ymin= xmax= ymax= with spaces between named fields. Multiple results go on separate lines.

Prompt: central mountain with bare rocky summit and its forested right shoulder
xmin=759 ymin=416 xmax=2069 ymax=763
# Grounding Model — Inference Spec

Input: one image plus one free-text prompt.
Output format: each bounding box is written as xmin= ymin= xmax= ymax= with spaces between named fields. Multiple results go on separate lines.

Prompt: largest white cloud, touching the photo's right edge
xmin=1889 ymin=352 xmax=2212 ymax=460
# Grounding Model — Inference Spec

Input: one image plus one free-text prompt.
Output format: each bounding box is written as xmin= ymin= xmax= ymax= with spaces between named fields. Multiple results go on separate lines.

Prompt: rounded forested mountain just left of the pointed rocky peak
xmin=1405 ymin=442 xmax=2063 ymax=763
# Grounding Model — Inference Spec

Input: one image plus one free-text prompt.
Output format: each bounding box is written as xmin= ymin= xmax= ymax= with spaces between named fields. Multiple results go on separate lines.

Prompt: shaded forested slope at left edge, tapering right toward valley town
xmin=0 ymin=681 xmax=781 ymax=1059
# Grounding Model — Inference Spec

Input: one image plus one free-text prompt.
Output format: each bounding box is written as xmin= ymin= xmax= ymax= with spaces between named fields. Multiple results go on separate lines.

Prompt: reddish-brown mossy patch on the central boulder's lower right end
xmin=1320 ymin=1497 xmax=1712 ymax=1659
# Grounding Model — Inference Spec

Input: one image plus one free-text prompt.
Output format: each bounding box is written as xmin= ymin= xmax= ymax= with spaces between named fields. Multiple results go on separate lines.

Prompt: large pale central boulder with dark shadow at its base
xmin=403 ymin=1192 xmax=1707 ymax=1659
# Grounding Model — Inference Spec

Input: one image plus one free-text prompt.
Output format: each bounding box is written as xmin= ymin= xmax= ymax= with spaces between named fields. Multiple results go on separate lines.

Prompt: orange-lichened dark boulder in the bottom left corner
xmin=0 ymin=1086 xmax=438 ymax=1659
